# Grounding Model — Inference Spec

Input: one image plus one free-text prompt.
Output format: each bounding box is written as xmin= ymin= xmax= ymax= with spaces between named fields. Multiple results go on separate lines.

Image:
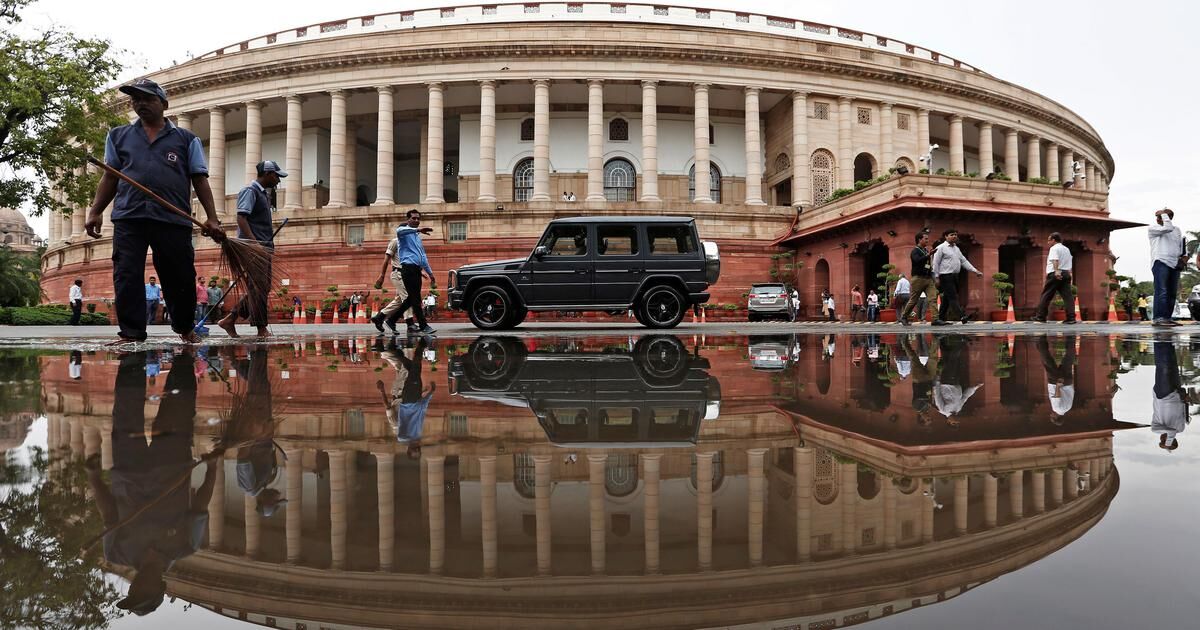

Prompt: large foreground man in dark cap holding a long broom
xmin=84 ymin=79 xmax=224 ymax=343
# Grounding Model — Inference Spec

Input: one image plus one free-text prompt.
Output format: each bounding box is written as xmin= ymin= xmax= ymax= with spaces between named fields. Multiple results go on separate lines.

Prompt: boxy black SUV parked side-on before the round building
xmin=448 ymin=216 xmax=721 ymax=330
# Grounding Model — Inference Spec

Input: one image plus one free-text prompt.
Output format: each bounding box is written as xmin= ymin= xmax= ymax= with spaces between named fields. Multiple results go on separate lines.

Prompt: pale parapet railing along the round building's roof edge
xmin=194 ymin=2 xmax=983 ymax=73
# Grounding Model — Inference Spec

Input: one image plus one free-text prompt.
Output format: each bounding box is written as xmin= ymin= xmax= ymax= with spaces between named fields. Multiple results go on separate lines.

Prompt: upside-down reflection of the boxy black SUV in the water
xmin=449 ymin=335 xmax=721 ymax=446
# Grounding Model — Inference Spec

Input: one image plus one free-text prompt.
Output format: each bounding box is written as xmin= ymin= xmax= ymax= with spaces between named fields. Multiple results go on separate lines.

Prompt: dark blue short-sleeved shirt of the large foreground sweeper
xmin=104 ymin=120 xmax=207 ymax=227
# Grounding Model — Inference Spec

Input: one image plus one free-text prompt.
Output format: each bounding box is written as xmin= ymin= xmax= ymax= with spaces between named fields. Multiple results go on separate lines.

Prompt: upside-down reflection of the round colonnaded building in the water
xmin=43 ymin=344 xmax=1121 ymax=629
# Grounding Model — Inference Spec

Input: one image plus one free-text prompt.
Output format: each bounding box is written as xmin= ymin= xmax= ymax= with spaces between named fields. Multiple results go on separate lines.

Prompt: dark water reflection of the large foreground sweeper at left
xmin=88 ymin=353 xmax=221 ymax=614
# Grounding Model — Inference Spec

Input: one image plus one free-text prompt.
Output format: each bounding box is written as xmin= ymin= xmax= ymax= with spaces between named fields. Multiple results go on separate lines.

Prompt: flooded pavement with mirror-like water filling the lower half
xmin=0 ymin=334 xmax=1200 ymax=630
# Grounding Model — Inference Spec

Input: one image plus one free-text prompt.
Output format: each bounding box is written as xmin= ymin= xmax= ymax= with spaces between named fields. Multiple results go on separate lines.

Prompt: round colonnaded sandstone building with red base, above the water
xmin=44 ymin=1 xmax=1122 ymax=319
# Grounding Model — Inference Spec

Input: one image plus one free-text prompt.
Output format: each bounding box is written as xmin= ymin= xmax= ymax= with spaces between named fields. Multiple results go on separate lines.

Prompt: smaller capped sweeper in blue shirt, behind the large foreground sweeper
xmin=217 ymin=160 xmax=288 ymax=337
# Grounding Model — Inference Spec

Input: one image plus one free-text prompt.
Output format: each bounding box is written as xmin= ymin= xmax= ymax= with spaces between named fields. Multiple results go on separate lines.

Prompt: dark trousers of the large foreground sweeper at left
xmin=113 ymin=218 xmax=196 ymax=341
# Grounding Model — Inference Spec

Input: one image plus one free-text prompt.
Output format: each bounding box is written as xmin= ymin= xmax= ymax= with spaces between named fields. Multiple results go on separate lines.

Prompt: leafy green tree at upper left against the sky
xmin=0 ymin=0 xmax=121 ymax=215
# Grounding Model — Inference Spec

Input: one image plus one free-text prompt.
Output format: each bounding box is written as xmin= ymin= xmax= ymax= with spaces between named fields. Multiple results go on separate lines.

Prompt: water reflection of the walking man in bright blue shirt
xmin=376 ymin=337 xmax=436 ymax=460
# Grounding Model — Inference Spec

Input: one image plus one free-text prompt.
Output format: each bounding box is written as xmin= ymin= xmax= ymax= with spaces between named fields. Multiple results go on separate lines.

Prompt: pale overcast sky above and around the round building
xmin=11 ymin=0 xmax=1200 ymax=280
